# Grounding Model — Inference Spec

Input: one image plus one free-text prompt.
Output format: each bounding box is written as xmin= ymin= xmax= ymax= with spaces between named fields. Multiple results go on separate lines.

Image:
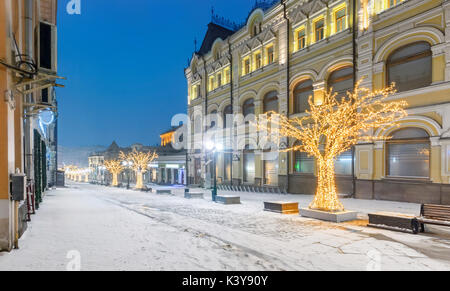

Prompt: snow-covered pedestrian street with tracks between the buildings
xmin=0 ymin=184 xmax=450 ymax=270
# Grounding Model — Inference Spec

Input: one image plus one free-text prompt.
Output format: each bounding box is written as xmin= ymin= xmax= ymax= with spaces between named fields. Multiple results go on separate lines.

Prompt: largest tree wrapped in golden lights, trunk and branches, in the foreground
xmin=258 ymin=82 xmax=407 ymax=212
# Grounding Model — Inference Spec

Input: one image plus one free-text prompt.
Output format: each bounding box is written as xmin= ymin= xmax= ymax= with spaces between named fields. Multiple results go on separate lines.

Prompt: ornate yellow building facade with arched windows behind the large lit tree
xmin=185 ymin=0 xmax=450 ymax=204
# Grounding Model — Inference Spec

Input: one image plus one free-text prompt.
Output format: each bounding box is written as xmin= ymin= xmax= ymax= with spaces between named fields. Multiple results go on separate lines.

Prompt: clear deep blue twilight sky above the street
xmin=57 ymin=0 xmax=255 ymax=146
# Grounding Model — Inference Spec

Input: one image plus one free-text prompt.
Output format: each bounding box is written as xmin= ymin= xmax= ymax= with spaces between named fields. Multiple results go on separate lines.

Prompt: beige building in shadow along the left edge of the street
xmin=0 ymin=0 xmax=59 ymax=251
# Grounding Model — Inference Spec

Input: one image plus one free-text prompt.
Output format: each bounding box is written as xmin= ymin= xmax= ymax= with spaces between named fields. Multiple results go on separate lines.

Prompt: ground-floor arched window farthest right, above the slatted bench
xmin=387 ymin=128 xmax=431 ymax=178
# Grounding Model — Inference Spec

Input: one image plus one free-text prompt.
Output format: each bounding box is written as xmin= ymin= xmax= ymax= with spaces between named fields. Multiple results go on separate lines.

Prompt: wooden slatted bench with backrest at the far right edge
xmin=414 ymin=204 xmax=450 ymax=234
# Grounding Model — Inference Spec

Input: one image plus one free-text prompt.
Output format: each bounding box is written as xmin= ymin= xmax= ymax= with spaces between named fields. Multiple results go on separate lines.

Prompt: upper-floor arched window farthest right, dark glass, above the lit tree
xmin=386 ymin=42 xmax=432 ymax=92
